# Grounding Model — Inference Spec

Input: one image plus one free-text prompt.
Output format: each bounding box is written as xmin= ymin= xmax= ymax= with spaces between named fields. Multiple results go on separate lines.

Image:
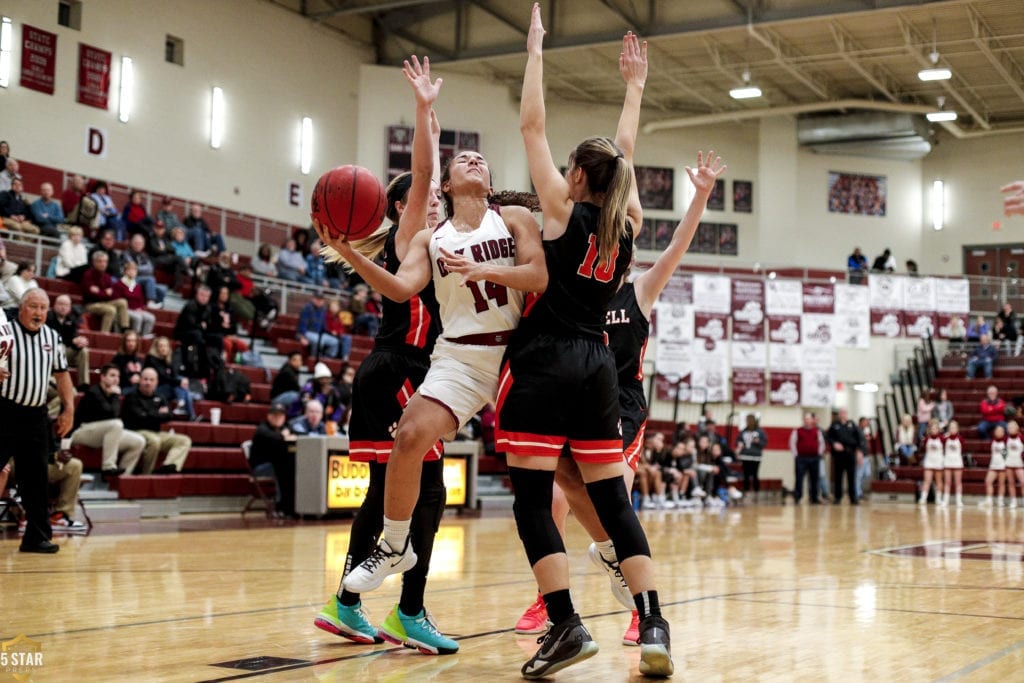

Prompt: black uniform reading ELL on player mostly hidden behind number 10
xmin=604 ymin=283 xmax=650 ymax=472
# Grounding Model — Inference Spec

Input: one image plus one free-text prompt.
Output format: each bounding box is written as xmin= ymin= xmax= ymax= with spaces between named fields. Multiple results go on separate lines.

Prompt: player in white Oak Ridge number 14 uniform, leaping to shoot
xmin=313 ymin=152 xmax=548 ymax=593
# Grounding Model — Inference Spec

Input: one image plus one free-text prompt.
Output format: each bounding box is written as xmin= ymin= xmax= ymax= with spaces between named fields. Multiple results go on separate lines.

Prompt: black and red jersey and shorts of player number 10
xmin=497 ymin=203 xmax=633 ymax=463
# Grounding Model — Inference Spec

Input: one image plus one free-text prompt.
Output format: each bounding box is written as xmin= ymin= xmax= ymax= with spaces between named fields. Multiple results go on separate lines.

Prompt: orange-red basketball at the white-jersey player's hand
xmin=311 ymin=164 xmax=387 ymax=240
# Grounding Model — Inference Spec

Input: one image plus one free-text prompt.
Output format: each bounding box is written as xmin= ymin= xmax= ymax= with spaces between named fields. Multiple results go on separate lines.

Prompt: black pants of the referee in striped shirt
xmin=0 ymin=398 xmax=53 ymax=546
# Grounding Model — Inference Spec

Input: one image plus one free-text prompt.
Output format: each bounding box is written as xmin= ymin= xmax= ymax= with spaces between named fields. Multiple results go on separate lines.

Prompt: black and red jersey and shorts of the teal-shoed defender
xmin=348 ymin=225 xmax=442 ymax=463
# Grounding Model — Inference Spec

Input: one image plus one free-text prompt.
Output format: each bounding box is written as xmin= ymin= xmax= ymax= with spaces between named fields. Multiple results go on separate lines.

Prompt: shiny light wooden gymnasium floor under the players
xmin=0 ymin=504 xmax=1024 ymax=683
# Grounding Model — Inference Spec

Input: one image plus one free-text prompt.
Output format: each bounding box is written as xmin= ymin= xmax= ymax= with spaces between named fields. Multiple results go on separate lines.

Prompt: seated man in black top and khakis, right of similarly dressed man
xmin=124 ymin=368 xmax=191 ymax=474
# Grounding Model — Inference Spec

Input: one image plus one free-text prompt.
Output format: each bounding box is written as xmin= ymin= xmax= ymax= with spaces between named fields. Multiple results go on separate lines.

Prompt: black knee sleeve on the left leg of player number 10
xmin=509 ymin=467 xmax=565 ymax=566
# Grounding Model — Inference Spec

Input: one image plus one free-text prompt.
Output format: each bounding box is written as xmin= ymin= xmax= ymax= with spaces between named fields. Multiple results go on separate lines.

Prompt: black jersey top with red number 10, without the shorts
xmin=519 ymin=203 xmax=633 ymax=338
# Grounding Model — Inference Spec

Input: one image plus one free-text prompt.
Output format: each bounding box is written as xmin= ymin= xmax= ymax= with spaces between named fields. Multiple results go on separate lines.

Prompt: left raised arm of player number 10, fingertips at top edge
xmin=519 ymin=2 xmax=572 ymax=235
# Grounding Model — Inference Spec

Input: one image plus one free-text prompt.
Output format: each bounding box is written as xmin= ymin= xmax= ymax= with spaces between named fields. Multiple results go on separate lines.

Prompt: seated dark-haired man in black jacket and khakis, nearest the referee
xmin=71 ymin=365 xmax=153 ymax=477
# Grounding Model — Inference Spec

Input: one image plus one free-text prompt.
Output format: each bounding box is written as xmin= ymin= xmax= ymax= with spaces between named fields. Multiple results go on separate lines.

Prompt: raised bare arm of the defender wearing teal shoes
xmin=395 ymin=54 xmax=443 ymax=260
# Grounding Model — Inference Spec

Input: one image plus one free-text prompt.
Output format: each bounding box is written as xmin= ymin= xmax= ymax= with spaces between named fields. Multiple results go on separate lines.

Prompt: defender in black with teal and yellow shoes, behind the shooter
xmin=313 ymin=57 xmax=459 ymax=654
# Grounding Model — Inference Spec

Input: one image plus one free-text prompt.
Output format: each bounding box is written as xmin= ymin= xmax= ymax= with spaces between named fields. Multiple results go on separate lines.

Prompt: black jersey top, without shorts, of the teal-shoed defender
xmin=374 ymin=224 xmax=440 ymax=354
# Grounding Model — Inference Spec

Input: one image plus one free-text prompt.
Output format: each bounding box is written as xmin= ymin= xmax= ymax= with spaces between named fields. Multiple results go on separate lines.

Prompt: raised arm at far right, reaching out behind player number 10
xmin=633 ymin=152 xmax=726 ymax=316
